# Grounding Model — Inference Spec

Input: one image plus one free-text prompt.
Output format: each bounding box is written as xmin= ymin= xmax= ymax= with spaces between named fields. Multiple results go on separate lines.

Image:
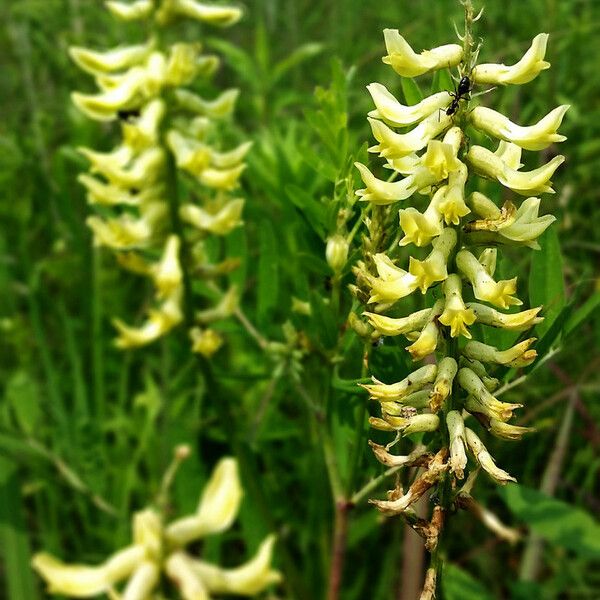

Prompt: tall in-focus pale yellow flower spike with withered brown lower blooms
xmin=355 ymin=24 xmax=568 ymax=549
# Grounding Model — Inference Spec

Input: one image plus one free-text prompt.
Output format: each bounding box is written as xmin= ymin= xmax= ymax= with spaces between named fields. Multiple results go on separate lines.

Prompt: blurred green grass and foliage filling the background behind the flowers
xmin=0 ymin=0 xmax=600 ymax=600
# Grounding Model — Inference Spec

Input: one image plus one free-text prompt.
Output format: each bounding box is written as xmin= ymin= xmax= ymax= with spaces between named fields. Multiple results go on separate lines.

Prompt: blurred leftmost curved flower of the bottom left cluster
xmin=32 ymin=546 xmax=145 ymax=598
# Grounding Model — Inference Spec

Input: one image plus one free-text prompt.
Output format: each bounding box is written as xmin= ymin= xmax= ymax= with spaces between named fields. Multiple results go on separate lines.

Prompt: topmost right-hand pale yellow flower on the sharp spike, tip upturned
xmin=471 ymin=33 xmax=550 ymax=85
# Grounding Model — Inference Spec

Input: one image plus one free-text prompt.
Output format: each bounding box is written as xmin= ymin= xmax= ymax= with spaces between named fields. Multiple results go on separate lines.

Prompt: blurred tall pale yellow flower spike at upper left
xmin=70 ymin=0 xmax=250 ymax=356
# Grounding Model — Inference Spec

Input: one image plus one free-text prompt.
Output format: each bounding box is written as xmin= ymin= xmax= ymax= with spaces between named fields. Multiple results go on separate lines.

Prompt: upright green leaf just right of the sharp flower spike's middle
xmin=529 ymin=227 xmax=565 ymax=337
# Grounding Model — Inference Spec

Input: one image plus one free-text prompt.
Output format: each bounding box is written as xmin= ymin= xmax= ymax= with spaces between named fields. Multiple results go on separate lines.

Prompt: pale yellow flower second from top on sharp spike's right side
xmin=469 ymin=104 xmax=569 ymax=150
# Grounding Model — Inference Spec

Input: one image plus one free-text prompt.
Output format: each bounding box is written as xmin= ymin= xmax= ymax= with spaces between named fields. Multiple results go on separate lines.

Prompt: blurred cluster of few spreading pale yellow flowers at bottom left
xmin=33 ymin=447 xmax=281 ymax=600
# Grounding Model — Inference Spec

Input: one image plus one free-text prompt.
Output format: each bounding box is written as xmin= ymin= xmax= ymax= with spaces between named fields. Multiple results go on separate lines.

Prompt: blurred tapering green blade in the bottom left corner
xmin=0 ymin=456 xmax=39 ymax=600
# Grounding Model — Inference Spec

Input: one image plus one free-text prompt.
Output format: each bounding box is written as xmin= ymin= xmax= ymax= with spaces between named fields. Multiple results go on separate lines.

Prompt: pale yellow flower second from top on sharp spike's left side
xmin=367 ymin=83 xmax=451 ymax=127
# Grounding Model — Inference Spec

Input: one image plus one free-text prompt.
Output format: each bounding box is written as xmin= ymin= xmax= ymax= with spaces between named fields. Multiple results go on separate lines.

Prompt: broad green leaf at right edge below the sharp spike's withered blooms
xmin=498 ymin=483 xmax=600 ymax=558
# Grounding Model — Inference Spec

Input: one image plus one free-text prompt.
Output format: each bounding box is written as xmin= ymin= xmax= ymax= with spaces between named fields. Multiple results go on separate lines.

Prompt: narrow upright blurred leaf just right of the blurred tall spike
xmin=256 ymin=221 xmax=279 ymax=327
